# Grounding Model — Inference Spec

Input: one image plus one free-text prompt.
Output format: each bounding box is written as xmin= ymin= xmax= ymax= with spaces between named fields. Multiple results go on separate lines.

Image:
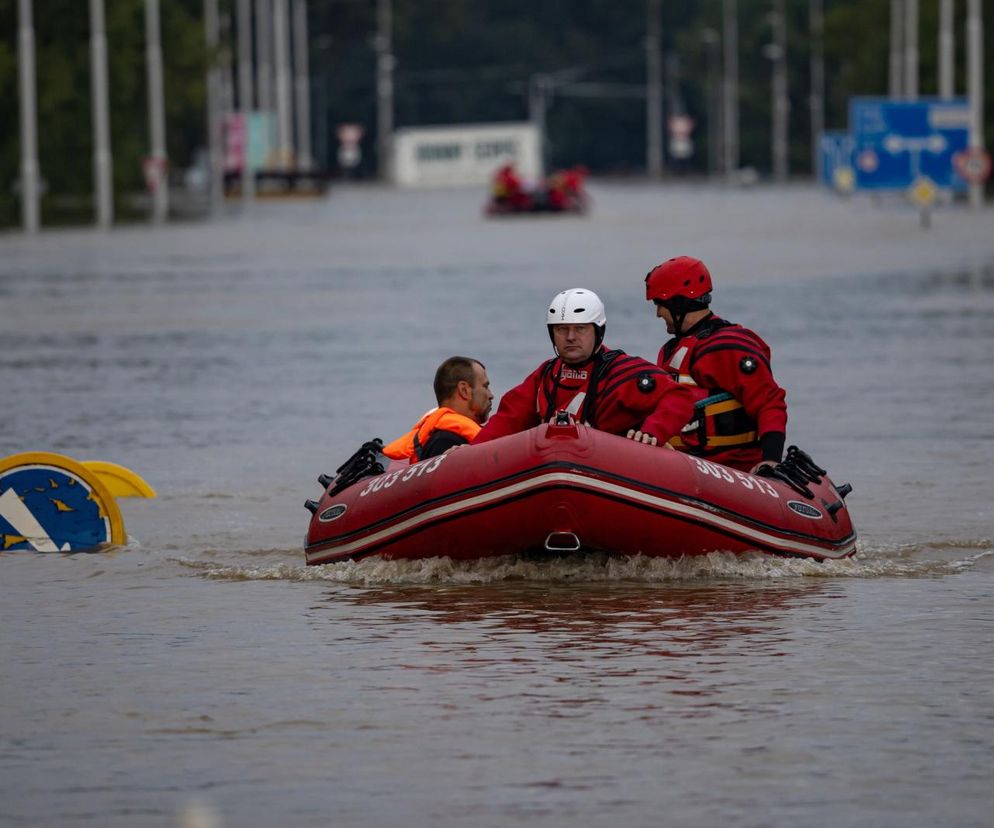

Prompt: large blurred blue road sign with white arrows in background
xmin=849 ymin=98 xmax=970 ymax=191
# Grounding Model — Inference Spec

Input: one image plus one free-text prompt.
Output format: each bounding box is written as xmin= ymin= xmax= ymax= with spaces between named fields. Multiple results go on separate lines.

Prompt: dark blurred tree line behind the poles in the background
xmin=0 ymin=0 xmax=994 ymax=225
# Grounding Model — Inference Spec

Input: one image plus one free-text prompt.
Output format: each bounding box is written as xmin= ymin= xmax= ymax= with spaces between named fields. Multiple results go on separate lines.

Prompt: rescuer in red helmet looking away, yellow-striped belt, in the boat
xmin=645 ymin=256 xmax=787 ymax=472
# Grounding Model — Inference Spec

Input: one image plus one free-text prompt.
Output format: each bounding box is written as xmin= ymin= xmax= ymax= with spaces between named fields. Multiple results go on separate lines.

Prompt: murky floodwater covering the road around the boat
xmin=0 ymin=183 xmax=994 ymax=826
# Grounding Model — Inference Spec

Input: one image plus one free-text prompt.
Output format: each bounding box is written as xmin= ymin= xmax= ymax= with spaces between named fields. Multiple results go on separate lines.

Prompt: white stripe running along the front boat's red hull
xmin=307 ymin=472 xmax=855 ymax=560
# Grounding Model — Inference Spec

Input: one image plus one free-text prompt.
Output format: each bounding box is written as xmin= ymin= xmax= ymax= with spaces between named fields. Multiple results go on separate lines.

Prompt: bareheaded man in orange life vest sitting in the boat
xmin=383 ymin=356 xmax=494 ymax=462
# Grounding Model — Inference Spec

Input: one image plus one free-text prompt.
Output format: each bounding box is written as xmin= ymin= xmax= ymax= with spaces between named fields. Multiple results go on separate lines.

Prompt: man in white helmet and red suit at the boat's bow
xmin=473 ymin=288 xmax=693 ymax=445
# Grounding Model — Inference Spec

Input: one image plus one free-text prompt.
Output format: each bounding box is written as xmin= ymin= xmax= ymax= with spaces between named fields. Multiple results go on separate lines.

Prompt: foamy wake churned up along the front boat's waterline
xmin=176 ymin=540 xmax=994 ymax=586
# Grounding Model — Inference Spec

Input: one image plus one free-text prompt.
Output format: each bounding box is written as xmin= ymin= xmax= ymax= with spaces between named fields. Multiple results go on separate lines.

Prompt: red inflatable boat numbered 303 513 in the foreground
xmin=306 ymin=423 xmax=856 ymax=564
